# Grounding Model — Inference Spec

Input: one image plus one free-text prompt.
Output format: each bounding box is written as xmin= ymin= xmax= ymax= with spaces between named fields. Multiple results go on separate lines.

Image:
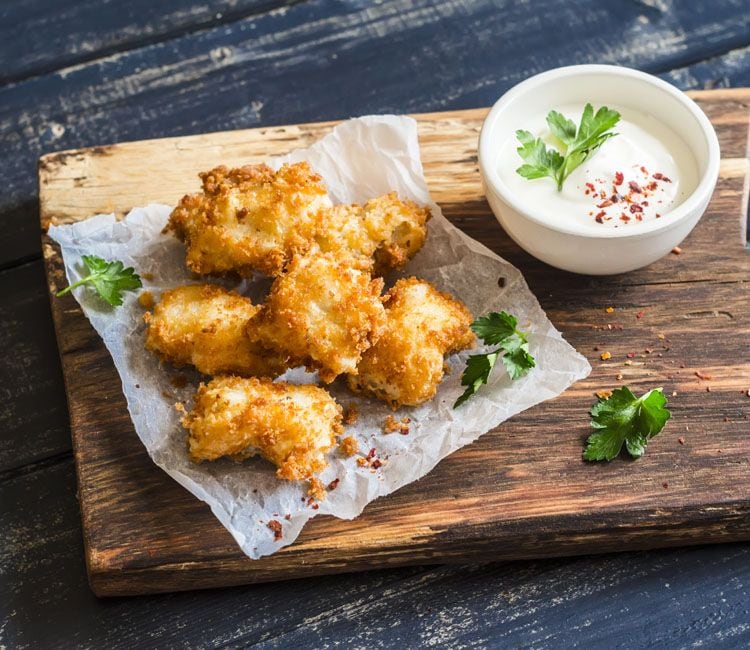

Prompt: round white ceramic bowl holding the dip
xmin=479 ymin=65 xmax=720 ymax=275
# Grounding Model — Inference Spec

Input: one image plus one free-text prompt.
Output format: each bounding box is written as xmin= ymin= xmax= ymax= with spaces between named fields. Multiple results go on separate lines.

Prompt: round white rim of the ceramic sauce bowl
xmin=478 ymin=64 xmax=721 ymax=239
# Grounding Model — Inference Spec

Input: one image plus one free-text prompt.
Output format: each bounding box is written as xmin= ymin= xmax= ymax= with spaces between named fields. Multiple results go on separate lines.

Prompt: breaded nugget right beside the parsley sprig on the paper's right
xmin=347 ymin=278 xmax=475 ymax=410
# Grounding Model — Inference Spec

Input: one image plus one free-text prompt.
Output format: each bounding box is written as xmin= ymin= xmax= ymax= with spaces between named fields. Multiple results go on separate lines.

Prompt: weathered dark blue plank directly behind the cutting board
xmin=0 ymin=0 xmax=750 ymax=266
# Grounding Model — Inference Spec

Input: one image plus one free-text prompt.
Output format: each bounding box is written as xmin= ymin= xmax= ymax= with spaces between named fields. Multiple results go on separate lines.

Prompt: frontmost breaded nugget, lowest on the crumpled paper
xmin=182 ymin=377 xmax=343 ymax=481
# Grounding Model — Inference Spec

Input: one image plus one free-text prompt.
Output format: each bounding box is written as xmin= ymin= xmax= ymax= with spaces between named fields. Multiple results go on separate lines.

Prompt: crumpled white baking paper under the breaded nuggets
xmin=49 ymin=115 xmax=591 ymax=558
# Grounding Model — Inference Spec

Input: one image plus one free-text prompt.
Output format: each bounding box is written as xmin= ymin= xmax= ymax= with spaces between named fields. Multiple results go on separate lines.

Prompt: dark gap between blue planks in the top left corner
xmin=0 ymin=0 xmax=307 ymax=88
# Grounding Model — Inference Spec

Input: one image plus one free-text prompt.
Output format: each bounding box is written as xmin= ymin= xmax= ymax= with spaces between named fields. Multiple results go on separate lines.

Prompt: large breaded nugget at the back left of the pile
xmin=167 ymin=162 xmax=331 ymax=276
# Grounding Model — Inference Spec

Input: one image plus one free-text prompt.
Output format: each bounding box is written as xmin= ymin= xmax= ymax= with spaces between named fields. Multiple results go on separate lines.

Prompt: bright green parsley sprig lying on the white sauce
xmin=516 ymin=104 xmax=620 ymax=191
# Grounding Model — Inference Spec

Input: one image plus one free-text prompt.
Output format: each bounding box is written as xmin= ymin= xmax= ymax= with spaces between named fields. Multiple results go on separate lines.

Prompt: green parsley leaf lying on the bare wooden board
xmin=583 ymin=386 xmax=672 ymax=460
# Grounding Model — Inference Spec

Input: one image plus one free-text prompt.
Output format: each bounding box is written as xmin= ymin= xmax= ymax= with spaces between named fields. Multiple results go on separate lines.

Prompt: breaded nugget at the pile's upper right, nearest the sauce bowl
xmin=316 ymin=192 xmax=431 ymax=275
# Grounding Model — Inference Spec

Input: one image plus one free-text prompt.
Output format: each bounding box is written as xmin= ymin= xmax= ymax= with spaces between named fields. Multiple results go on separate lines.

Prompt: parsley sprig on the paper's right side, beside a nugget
xmin=453 ymin=311 xmax=536 ymax=408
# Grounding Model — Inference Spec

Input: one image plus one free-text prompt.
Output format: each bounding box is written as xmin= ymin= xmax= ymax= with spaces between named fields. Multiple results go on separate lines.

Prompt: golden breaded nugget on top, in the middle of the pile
xmin=247 ymin=252 xmax=385 ymax=383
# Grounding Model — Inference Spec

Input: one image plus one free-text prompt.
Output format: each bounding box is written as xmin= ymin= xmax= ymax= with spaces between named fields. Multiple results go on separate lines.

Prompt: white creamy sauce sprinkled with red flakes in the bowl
xmin=498 ymin=103 xmax=698 ymax=232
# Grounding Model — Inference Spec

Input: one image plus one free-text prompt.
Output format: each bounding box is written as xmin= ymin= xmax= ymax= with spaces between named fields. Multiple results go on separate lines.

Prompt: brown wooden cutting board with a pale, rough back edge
xmin=39 ymin=89 xmax=750 ymax=596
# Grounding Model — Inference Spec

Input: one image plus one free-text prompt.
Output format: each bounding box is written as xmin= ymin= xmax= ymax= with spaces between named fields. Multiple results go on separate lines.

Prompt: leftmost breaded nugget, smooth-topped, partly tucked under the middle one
xmin=144 ymin=284 xmax=286 ymax=377
